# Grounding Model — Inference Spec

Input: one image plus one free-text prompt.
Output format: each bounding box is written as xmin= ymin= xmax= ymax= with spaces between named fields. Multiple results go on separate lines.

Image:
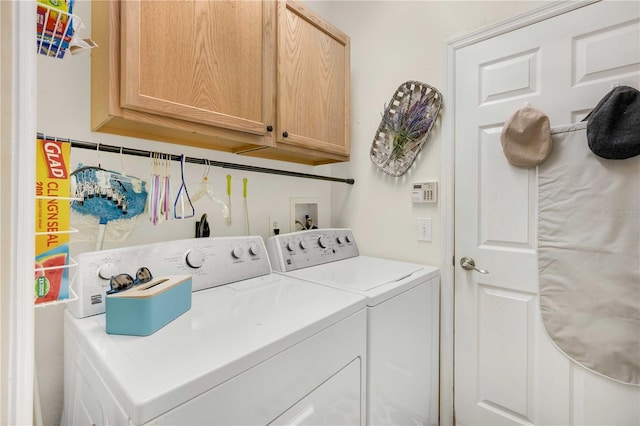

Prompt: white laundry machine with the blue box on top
xmin=62 ymin=237 xmax=366 ymax=426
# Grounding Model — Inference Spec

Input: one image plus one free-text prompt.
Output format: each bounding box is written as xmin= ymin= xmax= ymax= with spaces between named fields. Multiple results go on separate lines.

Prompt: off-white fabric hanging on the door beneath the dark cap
xmin=538 ymin=123 xmax=640 ymax=385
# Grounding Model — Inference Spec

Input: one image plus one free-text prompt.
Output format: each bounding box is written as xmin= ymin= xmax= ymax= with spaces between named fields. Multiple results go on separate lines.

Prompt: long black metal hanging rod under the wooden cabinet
xmin=38 ymin=133 xmax=355 ymax=185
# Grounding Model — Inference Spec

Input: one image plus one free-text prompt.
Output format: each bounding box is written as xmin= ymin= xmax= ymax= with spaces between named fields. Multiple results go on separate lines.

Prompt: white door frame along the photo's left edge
xmin=0 ymin=0 xmax=37 ymax=424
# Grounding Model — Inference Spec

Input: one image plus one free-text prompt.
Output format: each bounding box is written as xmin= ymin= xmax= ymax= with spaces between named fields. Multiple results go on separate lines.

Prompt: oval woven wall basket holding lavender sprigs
xmin=369 ymin=81 xmax=442 ymax=177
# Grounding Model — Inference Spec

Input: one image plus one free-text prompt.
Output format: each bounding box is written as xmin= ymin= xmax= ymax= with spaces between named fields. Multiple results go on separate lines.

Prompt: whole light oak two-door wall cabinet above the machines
xmin=91 ymin=0 xmax=349 ymax=164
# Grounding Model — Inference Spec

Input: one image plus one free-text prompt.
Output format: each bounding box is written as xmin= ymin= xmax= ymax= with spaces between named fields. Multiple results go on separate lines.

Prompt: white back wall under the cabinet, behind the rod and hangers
xmin=35 ymin=0 xmax=332 ymax=425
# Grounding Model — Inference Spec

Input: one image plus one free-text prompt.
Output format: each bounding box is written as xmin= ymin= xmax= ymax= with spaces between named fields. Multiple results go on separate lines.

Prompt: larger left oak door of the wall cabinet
xmin=120 ymin=0 xmax=275 ymax=134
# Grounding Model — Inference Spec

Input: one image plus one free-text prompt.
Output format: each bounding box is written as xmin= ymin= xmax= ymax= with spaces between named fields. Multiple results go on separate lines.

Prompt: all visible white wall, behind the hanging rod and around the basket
xmin=36 ymin=0 xmax=544 ymax=424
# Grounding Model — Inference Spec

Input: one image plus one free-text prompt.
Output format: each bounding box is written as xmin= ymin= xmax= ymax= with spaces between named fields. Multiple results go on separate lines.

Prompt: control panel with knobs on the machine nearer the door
xmin=267 ymin=228 xmax=360 ymax=272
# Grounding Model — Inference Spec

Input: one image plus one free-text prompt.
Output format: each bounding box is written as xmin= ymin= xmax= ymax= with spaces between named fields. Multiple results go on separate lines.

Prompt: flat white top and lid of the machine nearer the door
xmin=286 ymin=256 xmax=439 ymax=306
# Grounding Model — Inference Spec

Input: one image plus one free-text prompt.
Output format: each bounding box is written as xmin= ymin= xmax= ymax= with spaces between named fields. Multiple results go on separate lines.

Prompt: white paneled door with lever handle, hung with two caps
xmin=454 ymin=1 xmax=640 ymax=425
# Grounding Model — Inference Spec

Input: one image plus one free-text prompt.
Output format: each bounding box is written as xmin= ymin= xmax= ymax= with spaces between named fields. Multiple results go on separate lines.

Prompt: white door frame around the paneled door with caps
xmin=440 ymin=0 xmax=600 ymax=425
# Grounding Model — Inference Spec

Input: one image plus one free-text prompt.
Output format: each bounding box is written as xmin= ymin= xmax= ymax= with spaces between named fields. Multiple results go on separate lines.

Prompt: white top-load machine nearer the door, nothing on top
xmin=267 ymin=229 xmax=440 ymax=425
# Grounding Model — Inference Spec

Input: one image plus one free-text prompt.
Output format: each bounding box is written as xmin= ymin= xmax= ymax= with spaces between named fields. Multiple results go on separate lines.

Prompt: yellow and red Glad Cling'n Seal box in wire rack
xmin=34 ymin=139 xmax=71 ymax=303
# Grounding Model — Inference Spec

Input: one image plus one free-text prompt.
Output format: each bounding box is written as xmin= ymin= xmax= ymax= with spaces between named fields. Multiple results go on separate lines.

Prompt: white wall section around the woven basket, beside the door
xmin=320 ymin=1 xmax=549 ymax=265
